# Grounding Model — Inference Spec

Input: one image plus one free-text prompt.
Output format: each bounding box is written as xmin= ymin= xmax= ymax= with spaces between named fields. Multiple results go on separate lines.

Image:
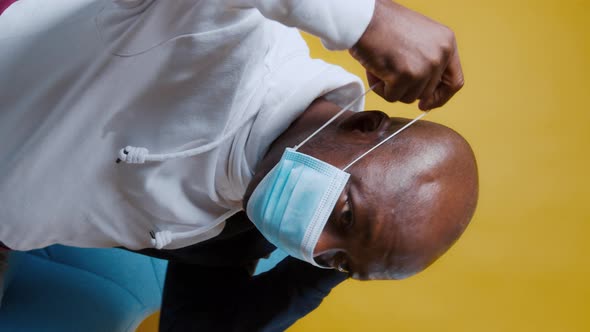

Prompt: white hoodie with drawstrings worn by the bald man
xmin=0 ymin=0 xmax=374 ymax=250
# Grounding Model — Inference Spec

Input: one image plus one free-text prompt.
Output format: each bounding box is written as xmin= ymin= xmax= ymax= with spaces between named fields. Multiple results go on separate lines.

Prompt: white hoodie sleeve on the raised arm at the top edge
xmin=229 ymin=0 xmax=375 ymax=50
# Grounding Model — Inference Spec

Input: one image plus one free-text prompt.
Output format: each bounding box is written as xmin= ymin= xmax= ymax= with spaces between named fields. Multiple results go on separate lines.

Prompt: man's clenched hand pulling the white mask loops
xmin=349 ymin=0 xmax=464 ymax=110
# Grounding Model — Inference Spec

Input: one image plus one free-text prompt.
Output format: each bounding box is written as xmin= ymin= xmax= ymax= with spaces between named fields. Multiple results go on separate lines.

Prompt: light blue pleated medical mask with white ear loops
xmin=246 ymin=89 xmax=426 ymax=267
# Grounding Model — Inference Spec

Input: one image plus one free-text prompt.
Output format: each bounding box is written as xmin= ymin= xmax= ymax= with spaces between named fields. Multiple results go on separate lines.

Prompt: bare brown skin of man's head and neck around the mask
xmin=244 ymin=99 xmax=478 ymax=280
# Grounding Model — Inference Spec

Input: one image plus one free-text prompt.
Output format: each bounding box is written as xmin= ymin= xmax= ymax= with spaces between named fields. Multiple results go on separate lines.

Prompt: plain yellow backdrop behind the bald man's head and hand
xmin=139 ymin=0 xmax=590 ymax=332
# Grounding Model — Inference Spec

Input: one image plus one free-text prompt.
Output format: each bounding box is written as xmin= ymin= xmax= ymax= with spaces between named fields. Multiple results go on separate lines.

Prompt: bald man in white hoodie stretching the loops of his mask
xmin=0 ymin=0 xmax=476 ymax=324
